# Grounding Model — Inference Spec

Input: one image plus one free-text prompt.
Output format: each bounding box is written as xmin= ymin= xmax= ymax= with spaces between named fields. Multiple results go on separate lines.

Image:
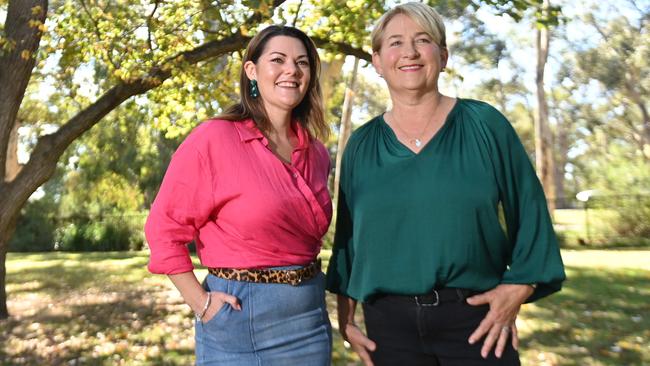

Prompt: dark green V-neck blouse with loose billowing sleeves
xmin=327 ymin=99 xmax=565 ymax=301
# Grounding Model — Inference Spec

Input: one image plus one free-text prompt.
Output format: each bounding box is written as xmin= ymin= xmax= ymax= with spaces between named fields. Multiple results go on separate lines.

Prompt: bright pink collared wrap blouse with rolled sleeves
xmin=144 ymin=120 xmax=332 ymax=274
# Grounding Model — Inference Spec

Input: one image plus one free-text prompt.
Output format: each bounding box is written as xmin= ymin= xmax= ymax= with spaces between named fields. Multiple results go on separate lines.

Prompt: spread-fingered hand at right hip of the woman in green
xmin=467 ymin=284 xmax=534 ymax=358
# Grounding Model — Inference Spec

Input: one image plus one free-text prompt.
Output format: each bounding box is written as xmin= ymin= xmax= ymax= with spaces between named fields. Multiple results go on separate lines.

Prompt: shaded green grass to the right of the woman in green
xmin=522 ymin=267 xmax=650 ymax=366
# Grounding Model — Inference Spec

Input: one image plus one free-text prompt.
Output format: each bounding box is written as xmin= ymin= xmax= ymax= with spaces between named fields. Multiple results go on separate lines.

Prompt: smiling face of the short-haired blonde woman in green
xmin=372 ymin=14 xmax=448 ymax=93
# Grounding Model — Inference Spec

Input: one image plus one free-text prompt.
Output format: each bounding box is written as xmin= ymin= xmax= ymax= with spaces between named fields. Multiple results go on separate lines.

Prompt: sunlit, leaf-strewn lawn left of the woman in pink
xmin=0 ymin=253 xmax=194 ymax=365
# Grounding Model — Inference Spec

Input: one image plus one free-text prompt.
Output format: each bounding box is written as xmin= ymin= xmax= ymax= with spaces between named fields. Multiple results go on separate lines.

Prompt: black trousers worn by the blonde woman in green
xmin=363 ymin=295 xmax=520 ymax=366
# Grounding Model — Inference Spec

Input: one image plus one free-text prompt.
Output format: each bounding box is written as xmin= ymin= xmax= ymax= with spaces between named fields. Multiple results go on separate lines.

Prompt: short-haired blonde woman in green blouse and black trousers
xmin=327 ymin=3 xmax=565 ymax=366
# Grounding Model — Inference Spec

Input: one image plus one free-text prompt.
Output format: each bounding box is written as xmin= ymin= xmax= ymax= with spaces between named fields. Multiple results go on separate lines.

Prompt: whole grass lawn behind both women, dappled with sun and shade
xmin=0 ymin=250 xmax=650 ymax=365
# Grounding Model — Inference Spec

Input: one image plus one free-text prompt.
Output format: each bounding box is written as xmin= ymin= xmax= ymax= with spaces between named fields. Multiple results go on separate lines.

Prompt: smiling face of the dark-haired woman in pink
xmin=244 ymin=36 xmax=311 ymax=115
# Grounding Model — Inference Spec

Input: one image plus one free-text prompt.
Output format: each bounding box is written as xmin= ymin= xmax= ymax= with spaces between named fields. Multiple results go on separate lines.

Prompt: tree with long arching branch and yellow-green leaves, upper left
xmin=0 ymin=0 xmax=556 ymax=318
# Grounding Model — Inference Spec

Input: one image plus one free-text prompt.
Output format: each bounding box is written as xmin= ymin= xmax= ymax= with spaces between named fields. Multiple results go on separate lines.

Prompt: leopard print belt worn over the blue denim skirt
xmin=208 ymin=258 xmax=321 ymax=286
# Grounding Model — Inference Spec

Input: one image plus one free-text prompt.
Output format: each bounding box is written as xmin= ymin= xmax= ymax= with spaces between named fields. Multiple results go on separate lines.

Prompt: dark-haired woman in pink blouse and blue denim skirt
xmin=145 ymin=26 xmax=332 ymax=365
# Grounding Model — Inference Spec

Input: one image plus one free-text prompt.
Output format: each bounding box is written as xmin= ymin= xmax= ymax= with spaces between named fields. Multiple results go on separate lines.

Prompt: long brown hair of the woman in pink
xmin=215 ymin=25 xmax=330 ymax=141
